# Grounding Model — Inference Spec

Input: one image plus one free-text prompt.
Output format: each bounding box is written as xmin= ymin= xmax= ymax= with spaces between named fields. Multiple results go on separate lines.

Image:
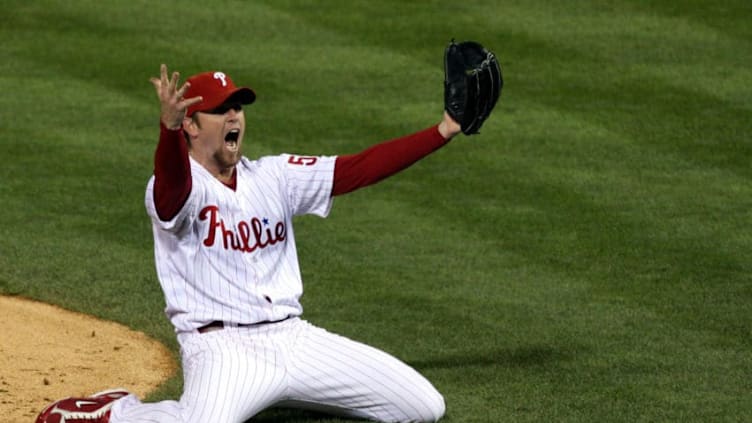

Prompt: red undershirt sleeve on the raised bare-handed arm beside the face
xmin=154 ymin=122 xmax=191 ymax=221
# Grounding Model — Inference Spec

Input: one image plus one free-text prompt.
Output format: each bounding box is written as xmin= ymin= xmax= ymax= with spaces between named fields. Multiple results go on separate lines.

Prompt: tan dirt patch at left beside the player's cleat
xmin=0 ymin=296 xmax=177 ymax=422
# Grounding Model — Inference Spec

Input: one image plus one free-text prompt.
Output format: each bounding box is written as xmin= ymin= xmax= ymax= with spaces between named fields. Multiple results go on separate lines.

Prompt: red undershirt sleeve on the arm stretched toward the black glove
xmin=332 ymin=125 xmax=449 ymax=196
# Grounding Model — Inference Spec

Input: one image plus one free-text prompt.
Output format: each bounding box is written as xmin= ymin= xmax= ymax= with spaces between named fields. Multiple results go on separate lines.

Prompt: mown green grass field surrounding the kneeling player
xmin=0 ymin=0 xmax=752 ymax=423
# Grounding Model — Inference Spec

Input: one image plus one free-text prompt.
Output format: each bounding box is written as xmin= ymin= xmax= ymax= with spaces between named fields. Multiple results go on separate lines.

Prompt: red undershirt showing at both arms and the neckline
xmin=154 ymin=122 xmax=448 ymax=221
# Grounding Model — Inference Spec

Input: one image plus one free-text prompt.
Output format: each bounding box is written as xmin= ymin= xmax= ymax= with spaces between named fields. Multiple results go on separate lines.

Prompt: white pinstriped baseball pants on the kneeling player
xmin=110 ymin=318 xmax=445 ymax=423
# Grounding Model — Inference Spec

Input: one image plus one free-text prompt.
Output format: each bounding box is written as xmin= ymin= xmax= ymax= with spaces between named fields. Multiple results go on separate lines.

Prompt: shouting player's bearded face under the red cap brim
xmin=191 ymin=103 xmax=245 ymax=172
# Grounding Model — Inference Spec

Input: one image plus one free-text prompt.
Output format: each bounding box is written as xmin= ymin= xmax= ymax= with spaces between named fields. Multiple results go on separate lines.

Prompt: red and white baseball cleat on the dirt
xmin=36 ymin=389 xmax=130 ymax=423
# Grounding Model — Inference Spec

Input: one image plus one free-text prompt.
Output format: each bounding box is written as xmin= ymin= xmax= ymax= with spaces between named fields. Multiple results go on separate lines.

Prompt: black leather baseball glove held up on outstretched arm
xmin=444 ymin=40 xmax=504 ymax=135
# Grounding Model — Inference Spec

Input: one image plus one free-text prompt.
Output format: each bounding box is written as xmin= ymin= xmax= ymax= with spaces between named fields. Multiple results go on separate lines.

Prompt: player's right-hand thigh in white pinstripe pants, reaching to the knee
xmin=287 ymin=322 xmax=444 ymax=422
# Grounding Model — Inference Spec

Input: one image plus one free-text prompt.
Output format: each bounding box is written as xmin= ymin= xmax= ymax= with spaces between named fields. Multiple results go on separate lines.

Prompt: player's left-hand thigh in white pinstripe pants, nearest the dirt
xmin=180 ymin=328 xmax=284 ymax=422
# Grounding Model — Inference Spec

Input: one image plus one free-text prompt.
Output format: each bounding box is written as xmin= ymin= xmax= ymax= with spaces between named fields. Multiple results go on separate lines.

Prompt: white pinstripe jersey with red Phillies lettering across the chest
xmin=145 ymin=154 xmax=335 ymax=332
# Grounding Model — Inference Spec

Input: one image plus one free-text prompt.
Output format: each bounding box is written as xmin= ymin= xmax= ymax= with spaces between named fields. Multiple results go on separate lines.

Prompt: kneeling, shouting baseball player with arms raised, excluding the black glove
xmin=37 ymin=41 xmax=502 ymax=423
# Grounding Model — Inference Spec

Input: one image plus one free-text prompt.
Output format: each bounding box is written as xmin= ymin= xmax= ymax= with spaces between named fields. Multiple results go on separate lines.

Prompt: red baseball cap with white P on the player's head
xmin=183 ymin=71 xmax=256 ymax=117
